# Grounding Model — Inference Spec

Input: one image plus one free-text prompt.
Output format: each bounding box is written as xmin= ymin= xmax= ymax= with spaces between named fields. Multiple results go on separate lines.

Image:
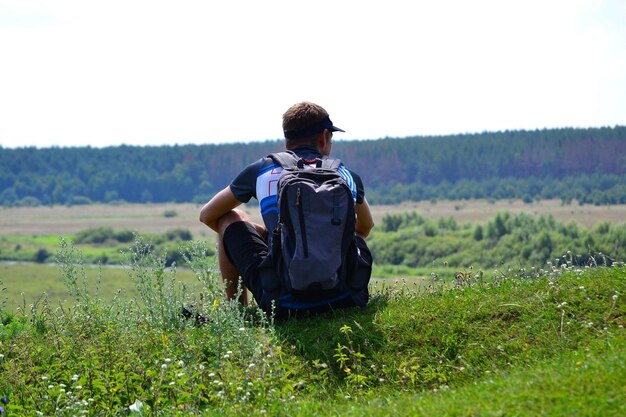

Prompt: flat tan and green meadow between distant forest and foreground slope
xmin=0 ymin=200 xmax=626 ymax=307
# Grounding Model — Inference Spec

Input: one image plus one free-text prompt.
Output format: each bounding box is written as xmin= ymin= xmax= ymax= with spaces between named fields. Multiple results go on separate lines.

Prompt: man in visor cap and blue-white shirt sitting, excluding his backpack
xmin=200 ymin=102 xmax=374 ymax=311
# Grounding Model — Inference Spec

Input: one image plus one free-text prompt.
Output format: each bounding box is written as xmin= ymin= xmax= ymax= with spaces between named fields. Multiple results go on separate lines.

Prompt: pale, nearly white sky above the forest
xmin=0 ymin=0 xmax=626 ymax=147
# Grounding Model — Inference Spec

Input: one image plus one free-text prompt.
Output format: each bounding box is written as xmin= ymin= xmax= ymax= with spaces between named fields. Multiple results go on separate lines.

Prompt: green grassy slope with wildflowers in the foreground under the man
xmin=0 ymin=242 xmax=626 ymax=416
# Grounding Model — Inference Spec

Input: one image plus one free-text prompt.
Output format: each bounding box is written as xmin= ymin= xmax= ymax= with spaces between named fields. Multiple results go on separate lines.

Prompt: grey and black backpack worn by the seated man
xmin=261 ymin=152 xmax=369 ymax=309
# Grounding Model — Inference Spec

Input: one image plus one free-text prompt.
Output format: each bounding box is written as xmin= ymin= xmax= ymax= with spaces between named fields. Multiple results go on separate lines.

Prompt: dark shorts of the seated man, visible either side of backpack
xmin=223 ymin=221 xmax=372 ymax=316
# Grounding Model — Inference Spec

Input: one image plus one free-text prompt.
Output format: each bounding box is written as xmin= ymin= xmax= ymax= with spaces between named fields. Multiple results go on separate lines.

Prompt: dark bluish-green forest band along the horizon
xmin=0 ymin=126 xmax=626 ymax=206
